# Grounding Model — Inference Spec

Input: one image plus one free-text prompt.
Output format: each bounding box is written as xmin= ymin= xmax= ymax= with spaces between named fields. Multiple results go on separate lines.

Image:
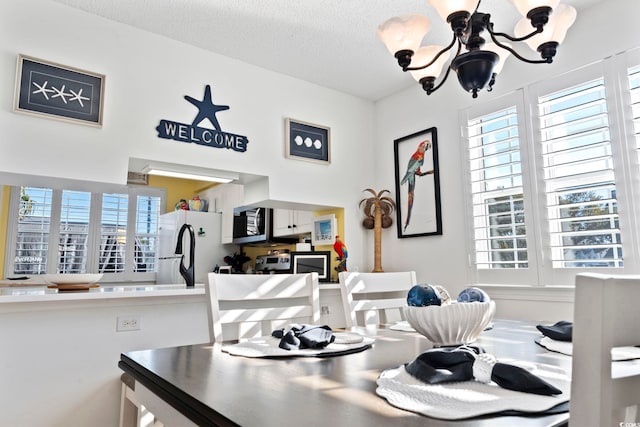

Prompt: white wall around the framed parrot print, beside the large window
xmin=374 ymin=0 xmax=640 ymax=319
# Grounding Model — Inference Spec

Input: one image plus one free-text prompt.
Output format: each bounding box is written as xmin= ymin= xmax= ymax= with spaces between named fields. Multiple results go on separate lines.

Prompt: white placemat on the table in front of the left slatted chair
xmin=222 ymin=332 xmax=375 ymax=357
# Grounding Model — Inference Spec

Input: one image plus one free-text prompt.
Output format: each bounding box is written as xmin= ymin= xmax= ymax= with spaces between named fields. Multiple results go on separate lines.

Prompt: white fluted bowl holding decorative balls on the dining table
xmin=403 ymin=301 xmax=496 ymax=346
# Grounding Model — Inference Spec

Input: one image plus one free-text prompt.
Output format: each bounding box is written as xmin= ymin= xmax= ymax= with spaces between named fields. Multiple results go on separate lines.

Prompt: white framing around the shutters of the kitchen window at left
xmin=4 ymin=184 xmax=166 ymax=283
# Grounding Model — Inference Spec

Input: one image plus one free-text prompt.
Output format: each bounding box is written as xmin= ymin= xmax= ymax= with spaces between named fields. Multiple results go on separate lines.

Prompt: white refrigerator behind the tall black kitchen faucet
xmin=156 ymin=210 xmax=228 ymax=284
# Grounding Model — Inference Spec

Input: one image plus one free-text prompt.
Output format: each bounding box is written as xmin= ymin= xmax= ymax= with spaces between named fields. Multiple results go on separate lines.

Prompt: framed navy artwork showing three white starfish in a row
xmin=14 ymin=55 xmax=105 ymax=127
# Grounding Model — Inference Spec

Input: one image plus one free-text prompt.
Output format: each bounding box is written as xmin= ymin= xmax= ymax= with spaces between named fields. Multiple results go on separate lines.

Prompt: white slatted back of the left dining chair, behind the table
xmin=206 ymin=273 xmax=320 ymax=342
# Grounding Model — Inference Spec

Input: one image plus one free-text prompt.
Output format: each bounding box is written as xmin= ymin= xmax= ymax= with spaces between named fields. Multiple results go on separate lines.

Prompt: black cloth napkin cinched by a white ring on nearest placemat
xmin=405 ymin=346 xmax=562 ymax=396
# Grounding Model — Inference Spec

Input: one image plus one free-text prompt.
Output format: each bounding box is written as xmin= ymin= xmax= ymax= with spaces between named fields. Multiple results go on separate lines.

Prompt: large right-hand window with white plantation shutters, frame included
xmin=460 ymin=55 xmax=640 ymax=286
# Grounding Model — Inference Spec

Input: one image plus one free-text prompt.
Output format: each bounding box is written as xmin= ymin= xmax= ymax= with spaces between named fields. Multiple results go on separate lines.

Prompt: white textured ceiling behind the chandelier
xmin=53 ymin=0 xmax=605 ymax=101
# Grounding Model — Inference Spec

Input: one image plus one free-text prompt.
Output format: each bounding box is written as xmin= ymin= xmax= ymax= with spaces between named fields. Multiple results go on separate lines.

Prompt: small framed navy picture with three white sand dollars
xmin=285 ymin=118 xmax=331 ymax=164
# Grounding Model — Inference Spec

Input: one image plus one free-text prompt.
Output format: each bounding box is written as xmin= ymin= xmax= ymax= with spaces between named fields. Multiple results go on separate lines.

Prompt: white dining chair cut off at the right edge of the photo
xmin=569 ymin=273 xmax=640 ymax=427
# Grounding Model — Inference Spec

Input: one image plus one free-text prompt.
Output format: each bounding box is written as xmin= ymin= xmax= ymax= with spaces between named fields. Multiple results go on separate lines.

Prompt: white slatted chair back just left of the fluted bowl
xmin=338 ymin=271 xmax=416 ymax=328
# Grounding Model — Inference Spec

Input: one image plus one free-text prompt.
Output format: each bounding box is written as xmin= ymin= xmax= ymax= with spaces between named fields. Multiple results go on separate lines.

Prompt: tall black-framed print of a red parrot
xmin=393 ymin=127 xmax=442 ymax=238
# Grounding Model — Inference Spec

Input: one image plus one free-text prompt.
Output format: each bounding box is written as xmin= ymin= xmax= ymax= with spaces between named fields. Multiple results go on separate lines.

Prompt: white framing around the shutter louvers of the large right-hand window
xmin=459 ymin=53 xmax=640 ymax=286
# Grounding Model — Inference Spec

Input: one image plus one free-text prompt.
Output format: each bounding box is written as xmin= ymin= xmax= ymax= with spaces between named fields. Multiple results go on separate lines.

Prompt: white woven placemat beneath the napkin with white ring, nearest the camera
xmin=376 ymin=362 xmax=571 ymax=420
